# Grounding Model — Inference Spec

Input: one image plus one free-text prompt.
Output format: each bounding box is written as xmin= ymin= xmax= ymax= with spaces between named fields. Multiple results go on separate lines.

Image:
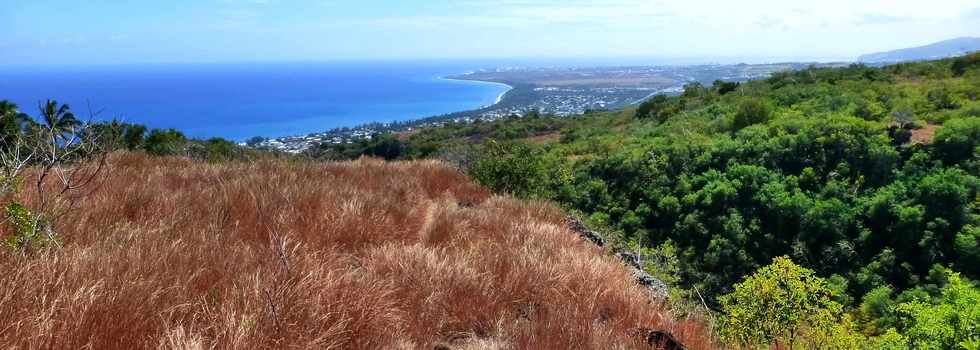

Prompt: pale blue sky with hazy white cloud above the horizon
xmin=0 ymin=0 xmax=980 ymax=65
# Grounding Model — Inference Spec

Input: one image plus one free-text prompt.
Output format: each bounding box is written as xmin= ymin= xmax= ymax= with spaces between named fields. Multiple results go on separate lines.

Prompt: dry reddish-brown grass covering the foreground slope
xmin=0 ymin=153 xmax=711 ymax=349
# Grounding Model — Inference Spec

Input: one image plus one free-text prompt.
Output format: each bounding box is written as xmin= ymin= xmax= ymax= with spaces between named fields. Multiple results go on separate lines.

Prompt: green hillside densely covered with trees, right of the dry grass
xmin=317 ymin=54 xmax=980 ymax=349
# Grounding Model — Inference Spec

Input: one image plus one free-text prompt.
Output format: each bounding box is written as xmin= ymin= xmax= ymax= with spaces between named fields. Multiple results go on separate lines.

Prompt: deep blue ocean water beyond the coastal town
xmin=0 ymin=62 xmax=508 ymax=140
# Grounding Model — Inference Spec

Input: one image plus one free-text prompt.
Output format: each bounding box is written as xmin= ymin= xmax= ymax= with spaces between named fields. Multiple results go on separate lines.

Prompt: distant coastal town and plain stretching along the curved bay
xmin=244 ymin=63 xmax=848 ymax=153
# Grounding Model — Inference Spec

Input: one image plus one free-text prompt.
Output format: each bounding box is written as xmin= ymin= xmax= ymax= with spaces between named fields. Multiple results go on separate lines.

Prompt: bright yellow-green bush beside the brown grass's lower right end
xmin=719 ymin=257 xmax=860 ymax=349
